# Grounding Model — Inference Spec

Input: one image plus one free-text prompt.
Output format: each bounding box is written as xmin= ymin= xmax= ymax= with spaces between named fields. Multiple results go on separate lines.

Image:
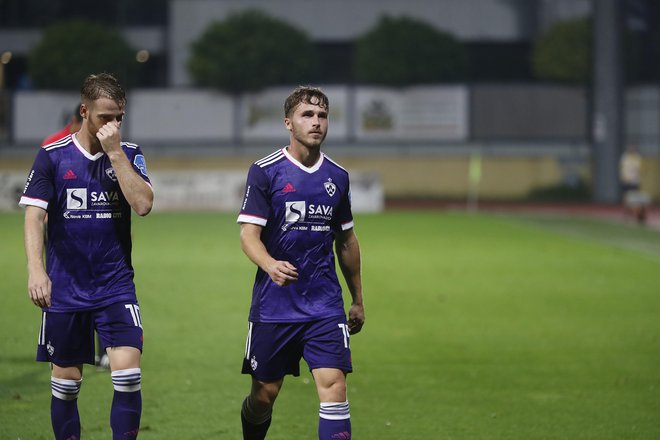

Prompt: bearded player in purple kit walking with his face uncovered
xmin=238 ymin=87 xmax=364 ymax=440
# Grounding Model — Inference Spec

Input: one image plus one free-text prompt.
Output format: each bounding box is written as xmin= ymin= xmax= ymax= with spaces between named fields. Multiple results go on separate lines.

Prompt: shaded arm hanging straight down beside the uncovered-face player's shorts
xmin=335 ymin=228 xmax=365 ymax=334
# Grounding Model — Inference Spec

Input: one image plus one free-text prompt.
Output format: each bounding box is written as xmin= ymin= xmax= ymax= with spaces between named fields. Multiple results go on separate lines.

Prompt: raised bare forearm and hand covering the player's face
xmin=96 ymin=121 xmax=154 ymax=216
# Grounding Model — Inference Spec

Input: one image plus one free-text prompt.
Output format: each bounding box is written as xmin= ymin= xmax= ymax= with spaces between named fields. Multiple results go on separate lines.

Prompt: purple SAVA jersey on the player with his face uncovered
xmin=238 ymin=149 xmax=353 ymax=322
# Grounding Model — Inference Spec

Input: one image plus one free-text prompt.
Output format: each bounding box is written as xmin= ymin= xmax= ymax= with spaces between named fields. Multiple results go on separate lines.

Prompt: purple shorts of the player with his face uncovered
xmin=242 ymin=316 xmax=353 ymax=382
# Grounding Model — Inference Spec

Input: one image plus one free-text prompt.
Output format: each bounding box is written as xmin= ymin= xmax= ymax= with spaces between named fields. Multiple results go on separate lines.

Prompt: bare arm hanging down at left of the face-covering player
xmin=25 ymin=206 xmax=52 ymax=307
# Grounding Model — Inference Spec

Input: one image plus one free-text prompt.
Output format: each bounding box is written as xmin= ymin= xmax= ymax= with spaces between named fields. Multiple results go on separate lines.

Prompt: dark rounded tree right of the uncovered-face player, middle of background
xmin=355 ymin=16 xmax=468 ymax=87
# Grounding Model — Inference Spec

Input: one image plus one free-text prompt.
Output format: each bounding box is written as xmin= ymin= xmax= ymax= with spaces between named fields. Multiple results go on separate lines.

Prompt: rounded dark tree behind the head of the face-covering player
xmin=28 ymin=20 xmax=138 ymax=90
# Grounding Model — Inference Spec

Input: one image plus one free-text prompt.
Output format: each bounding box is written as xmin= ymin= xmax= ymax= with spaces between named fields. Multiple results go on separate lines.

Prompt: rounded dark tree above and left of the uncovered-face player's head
xmin=188 ymin=10 xmax=318 ymax=93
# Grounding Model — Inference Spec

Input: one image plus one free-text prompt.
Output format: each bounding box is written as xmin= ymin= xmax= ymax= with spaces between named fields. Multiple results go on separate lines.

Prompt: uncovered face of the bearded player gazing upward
xmin=284 ymin=102 xmax=328 ymax=148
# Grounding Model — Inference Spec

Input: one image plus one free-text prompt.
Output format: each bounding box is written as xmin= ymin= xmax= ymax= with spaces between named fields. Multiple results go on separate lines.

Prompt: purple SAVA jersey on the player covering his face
xmin=19 ymin=135 xmax=150 ymax=312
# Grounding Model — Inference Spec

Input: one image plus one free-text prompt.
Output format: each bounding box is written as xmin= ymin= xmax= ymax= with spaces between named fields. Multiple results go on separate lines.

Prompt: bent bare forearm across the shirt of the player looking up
xmin=241 ymin=223 xmax=298 ymax=286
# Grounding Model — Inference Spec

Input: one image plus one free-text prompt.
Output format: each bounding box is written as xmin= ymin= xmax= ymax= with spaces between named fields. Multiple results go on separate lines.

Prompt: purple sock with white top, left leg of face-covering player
xmin=50 ymin=377 xmax=82 ymax=440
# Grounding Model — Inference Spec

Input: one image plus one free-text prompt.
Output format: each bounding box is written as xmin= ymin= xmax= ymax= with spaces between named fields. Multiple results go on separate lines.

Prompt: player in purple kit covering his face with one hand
xmin=20 ymin=73 xmax=153 ymax=439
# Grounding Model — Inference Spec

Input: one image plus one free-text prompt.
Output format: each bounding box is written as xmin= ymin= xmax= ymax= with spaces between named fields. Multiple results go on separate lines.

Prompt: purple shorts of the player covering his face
xmin=37 ymin=302 xmax=143 ymax=367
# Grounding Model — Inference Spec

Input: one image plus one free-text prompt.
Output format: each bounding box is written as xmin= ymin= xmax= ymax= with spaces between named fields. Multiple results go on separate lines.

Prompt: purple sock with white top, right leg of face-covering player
xmin=110 ymin=368 xmax=142 ymax=440
